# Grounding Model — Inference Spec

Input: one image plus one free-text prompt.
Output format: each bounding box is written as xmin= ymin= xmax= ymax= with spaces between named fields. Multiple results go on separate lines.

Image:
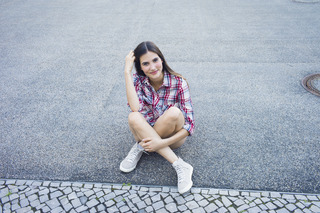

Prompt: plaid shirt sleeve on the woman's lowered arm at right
xmin=178 ymin=79 xmax=194 ymax=136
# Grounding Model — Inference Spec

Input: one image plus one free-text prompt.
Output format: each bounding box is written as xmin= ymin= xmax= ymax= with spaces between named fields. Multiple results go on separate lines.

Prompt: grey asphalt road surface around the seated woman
xmin=0 ymin=0 xmax=320 ymax=193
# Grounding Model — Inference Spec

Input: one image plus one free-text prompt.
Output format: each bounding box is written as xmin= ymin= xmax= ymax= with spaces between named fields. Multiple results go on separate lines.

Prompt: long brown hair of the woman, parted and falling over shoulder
xmin=134 ymin=41 xmax=186 ymax=80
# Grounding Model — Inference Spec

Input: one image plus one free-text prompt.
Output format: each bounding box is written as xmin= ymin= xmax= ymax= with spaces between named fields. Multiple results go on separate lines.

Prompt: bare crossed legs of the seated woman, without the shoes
xmin=128 ymin=107 xmax=186 ymax=164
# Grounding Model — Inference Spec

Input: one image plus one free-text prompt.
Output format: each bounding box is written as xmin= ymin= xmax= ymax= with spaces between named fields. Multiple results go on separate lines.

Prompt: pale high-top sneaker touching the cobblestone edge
xmin=172 ymin=158 xmax=193 ymax=194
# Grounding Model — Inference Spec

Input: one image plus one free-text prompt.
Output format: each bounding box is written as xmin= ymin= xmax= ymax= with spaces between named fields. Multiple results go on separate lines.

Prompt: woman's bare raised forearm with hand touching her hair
xmin=124 ymin=51 xmax=140 ymax=112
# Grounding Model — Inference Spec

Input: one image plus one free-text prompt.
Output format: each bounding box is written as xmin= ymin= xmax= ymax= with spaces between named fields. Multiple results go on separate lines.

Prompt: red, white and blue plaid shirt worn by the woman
xmin=133 ymin=71 xmax=194 ymax=136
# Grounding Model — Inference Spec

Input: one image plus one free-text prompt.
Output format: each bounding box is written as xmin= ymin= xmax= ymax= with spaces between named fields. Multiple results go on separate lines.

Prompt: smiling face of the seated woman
xmin=140 ymin=51 xmax=163 ymax=81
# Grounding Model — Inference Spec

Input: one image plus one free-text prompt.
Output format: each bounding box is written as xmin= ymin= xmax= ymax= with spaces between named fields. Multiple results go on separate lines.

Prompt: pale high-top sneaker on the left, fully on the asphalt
xmin=120 ymin=143 xmax=144 ymax=172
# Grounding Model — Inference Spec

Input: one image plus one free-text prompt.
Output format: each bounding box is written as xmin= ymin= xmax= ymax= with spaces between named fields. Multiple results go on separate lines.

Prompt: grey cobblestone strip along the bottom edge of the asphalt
xmin=0 ymin=180 xmax=320 ymax=213
